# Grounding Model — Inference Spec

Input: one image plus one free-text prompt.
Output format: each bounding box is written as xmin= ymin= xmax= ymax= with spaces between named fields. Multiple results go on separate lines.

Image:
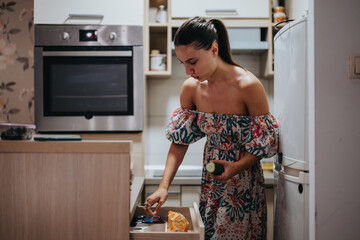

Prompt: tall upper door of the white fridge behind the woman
xmin=274 ymin=19 xmax=309 ymax=170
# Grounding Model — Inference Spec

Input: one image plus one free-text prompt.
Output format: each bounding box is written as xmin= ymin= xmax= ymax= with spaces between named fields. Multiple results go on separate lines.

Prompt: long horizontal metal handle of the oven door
xmin=42 ymin=51 xmax=132 ymax=57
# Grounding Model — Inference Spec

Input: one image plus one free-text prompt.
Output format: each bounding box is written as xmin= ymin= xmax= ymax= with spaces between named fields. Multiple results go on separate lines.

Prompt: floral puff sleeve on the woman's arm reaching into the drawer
xmin=166 ymin=108 xmax=204 ymax=145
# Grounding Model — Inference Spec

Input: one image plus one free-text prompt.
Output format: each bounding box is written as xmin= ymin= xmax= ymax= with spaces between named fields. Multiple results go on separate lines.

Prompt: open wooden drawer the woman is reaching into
xmin=130 ymin=203 xmax=204 ymax=240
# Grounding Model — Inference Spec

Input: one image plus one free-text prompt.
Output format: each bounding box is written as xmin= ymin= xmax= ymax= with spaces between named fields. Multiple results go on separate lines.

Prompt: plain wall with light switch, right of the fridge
xmin=311 ymin=0 xmax=360 ymax=240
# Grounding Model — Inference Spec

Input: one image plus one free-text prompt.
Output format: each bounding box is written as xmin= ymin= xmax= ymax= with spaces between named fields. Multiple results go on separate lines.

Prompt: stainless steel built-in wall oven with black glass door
xmin=34 ymin=25 xmax=144 ymax=132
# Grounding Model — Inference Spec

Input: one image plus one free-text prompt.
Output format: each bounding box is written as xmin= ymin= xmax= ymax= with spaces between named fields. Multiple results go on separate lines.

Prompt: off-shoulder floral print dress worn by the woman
xmin=166 ymin=108 xmax=278 ymax=240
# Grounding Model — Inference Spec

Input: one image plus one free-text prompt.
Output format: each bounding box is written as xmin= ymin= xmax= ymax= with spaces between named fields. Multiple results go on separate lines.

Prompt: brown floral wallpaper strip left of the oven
xmin=0 ymin=0 xmax=34 ymax=124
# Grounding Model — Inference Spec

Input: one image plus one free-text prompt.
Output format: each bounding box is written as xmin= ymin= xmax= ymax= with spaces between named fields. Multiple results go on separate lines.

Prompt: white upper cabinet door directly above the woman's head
xmin=171 ymin=0 xmax=270 ymax=18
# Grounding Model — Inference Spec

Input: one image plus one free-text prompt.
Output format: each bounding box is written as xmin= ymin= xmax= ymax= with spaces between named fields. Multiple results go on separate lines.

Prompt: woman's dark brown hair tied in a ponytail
xmin=174 ymin=17 xmax=243 ymax=68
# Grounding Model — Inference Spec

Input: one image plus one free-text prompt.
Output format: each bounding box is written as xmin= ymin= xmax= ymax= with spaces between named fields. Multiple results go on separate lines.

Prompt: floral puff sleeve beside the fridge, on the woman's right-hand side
xmin=243 ymin=113 xmax=279 ymax=158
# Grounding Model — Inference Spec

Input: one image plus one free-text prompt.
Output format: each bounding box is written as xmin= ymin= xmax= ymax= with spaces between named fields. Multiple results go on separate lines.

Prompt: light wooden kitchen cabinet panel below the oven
xmin=0 ymin=140 xmax=132 ymax=240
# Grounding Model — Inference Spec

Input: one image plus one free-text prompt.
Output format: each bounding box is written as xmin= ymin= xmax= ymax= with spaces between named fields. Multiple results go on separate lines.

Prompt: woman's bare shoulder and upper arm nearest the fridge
xmin=239 ymin=69 xmax=269 ymax=116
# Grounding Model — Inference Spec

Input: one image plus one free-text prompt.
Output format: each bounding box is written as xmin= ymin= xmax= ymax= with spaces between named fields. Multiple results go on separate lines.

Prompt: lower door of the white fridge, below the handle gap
xmin=274 ymin=165 xmax=309 ymax=240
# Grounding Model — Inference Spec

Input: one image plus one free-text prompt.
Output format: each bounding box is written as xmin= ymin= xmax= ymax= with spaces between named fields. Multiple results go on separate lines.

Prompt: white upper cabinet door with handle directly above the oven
xmin=34 ymin=0 xmax=144 ymax=25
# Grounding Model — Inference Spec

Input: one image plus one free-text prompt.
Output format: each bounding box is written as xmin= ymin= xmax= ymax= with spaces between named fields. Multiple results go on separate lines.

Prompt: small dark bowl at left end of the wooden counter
xmin=0 ymin=123 xmax=35 ymax=140
